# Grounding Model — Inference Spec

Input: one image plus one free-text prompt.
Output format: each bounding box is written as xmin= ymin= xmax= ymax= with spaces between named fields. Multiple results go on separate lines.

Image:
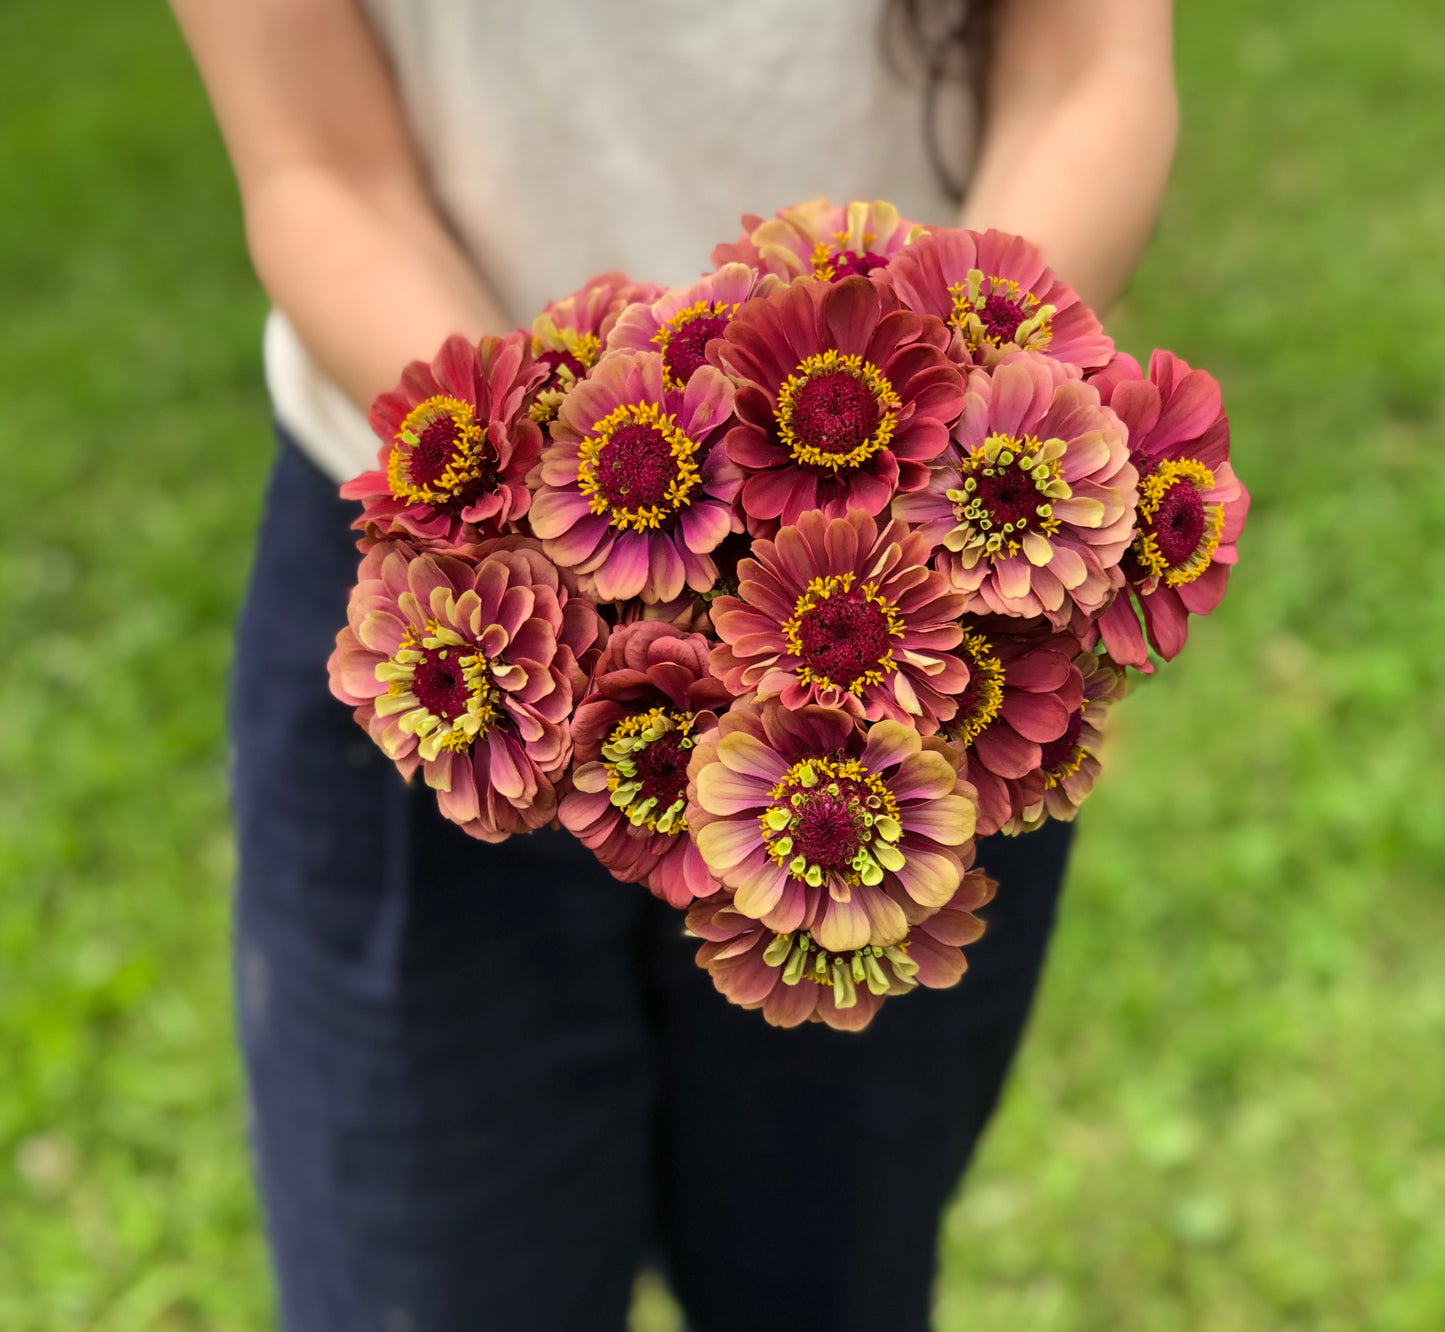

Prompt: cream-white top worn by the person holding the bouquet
xmin=266 ymin=0 xmax=972 ymax=481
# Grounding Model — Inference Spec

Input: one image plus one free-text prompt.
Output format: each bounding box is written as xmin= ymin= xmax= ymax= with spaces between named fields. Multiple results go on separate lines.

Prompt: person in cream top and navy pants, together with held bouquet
xmin=172 ymin=0 xmax=1184 ymax=1332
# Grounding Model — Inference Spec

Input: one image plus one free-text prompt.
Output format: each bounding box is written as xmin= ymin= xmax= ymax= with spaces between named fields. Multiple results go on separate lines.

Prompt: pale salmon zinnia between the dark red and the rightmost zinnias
xmin=893 ymin=355 xmax=1137 ymax=627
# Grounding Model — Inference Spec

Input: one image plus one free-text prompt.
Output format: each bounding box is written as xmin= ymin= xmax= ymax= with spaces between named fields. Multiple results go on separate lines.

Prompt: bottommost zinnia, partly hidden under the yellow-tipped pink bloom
xmin=688 ymin=870 xmax=997 ymax=1032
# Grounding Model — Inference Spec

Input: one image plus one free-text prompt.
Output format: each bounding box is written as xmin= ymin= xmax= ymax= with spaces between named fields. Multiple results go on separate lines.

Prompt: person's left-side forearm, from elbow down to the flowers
xmin=246 ymin=166 xmax=504 ymax=409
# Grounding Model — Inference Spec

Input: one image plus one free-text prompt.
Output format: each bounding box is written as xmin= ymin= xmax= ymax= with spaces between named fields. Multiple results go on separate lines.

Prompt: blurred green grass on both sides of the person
xmin=0 ymin=0 xmax=1445 ymax=1332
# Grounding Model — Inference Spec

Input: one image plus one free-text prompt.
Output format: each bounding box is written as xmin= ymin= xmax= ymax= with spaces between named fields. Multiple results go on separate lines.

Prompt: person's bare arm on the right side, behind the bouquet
xmin=962 ymin=0 xmax=1179 ymax=311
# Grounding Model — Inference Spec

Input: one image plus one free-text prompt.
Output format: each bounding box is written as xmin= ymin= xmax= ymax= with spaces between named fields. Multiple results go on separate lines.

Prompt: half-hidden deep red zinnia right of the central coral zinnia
xmin=942 ymin=615 xmax=1084 ymax=836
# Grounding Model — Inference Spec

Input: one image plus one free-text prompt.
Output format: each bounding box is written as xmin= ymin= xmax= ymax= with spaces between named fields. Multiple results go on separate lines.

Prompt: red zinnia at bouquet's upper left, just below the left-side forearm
xmin=341 ymin=331 xmax=546 ymax=548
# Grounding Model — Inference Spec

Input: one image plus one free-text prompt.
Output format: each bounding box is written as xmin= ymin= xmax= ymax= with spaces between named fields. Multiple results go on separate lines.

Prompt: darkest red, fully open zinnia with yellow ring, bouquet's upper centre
xmin=711 ymin=277 xmax=964 ymax=535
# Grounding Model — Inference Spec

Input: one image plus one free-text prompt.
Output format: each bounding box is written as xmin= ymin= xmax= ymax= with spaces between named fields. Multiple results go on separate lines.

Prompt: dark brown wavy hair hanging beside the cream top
xmin=883 ymin=0 xmax=998 ymax=201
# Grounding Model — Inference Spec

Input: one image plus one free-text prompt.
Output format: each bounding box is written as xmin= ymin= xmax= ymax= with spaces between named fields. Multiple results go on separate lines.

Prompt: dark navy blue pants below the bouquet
xmin=231 ymin=439 xmax=1069 ymax=1332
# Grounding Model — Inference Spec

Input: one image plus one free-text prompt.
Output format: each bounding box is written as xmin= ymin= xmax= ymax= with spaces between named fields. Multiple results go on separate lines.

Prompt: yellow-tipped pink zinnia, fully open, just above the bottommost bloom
xmin=688 ymin=701 xmax=975 ymax=953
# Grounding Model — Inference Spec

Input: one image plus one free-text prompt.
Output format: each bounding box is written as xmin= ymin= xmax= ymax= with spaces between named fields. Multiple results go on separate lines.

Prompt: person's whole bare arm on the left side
xmin=172 ymin=0 xmax=503 ymax=410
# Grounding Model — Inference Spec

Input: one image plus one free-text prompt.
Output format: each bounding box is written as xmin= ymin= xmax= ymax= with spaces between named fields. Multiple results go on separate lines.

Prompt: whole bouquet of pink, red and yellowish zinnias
xmin=331 ymin=199 xmax=1248 ymax=1029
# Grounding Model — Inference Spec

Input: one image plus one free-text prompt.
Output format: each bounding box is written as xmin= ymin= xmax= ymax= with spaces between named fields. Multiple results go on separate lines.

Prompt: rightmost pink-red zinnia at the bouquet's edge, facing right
xmin=1091 ymin=351 xmax=1250 ymax=672
